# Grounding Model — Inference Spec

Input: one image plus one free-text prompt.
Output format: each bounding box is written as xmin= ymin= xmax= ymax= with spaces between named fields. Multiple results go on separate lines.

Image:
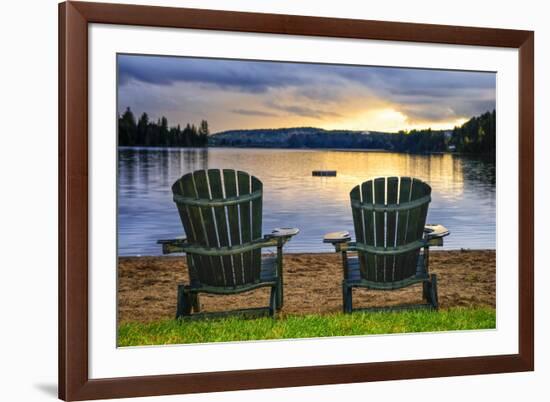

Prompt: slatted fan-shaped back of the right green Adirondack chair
xmin=350 ymin=177 xmax=431 ymax=282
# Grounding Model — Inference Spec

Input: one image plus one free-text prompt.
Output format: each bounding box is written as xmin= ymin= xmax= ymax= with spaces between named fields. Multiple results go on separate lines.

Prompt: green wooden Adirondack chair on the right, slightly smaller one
xmin=324 ymin=177 xmax=449 ymax=313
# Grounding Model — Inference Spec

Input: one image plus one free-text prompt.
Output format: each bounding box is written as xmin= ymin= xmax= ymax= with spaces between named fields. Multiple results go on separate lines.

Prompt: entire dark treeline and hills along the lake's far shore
xmin=118 ymin=108 xmax=496 ymax=156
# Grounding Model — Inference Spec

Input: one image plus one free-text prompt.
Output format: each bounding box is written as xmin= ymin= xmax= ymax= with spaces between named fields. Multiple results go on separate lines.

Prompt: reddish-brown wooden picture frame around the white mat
xmin=59 ymin=2 xmax=534 ymax=400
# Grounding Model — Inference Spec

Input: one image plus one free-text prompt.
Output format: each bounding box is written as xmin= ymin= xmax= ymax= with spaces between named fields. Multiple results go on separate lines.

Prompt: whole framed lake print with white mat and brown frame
xmin=59 ymin=2 xmax=534 ymax=400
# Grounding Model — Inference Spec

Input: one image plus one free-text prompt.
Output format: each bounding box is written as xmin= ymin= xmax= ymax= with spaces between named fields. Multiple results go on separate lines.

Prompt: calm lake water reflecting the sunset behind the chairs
xmin=118 ymin=148 xmax=496 ymax=256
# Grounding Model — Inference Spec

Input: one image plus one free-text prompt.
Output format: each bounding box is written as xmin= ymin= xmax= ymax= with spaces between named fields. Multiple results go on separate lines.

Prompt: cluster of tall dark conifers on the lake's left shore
xmin=118 ymin=108 xmax=209 ymax=147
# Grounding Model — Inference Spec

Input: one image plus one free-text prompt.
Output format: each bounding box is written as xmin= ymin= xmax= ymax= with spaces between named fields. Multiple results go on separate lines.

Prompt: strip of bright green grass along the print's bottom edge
xmin=118 ymin=308 xmax=496 ymax=346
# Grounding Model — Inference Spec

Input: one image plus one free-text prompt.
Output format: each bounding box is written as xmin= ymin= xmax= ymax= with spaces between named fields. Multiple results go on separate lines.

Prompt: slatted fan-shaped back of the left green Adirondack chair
xmin=172 ymin=169 xmax=262 ymax=287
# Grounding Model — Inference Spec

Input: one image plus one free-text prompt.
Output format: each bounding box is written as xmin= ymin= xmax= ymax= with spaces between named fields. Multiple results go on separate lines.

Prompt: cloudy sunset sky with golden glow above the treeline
xmin=118 ymin=55 xmax=496 ymax=132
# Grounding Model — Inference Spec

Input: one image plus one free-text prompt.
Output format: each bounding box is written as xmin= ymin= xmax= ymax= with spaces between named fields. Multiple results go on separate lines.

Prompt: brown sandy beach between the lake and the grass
xmin=118 ymin=250 xmax=496 ymax=324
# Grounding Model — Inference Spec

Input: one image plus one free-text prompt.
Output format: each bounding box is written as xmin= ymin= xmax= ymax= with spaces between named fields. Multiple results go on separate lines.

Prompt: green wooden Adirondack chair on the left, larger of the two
xmin=158 ymin=169 xmax=299 ymax=318
